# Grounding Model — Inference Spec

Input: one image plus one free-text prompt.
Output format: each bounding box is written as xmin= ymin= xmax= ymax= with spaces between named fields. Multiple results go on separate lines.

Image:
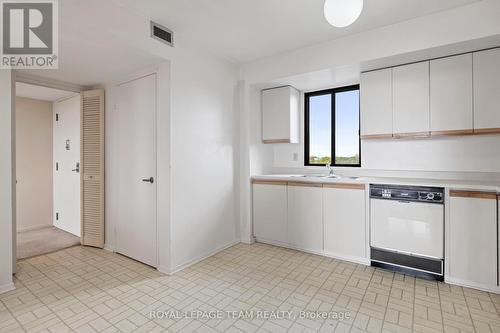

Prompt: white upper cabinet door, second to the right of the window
xmin=392 ymin=61 xmax=430 ymax=136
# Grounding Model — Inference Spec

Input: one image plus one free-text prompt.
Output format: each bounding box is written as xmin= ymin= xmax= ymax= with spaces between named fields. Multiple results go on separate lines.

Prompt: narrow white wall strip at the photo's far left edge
xmin=0 ymin=69 xmax=14 ymax=293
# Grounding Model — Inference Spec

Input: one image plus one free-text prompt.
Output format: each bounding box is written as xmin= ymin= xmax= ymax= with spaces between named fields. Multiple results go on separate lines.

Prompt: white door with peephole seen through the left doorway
xmin=53 ymin=94 xmax=81 ymax=237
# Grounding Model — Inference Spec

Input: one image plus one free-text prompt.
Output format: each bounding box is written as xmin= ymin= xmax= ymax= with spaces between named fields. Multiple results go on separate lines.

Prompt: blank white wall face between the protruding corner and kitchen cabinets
xmin=171 ymin=52 xmax=239 ymax=270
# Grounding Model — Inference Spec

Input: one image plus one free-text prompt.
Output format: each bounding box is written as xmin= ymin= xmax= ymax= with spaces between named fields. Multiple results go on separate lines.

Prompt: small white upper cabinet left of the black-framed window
xmin=262 ymin=86 xmax=300 ymax=143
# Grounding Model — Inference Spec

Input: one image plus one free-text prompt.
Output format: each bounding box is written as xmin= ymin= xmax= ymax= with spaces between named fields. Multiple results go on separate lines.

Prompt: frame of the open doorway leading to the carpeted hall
xmin=11 ymin=70 xmax=84 ymax=274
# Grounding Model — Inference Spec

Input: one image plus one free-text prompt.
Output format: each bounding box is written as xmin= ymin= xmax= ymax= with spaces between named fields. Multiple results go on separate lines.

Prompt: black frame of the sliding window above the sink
xmin=304 ymin=84 xmax=361 ymax=168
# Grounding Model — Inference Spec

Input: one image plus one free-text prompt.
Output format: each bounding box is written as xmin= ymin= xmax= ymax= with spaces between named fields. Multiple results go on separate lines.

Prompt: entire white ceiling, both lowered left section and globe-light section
xmin=18 ymin=0 xmax=478 ymax=87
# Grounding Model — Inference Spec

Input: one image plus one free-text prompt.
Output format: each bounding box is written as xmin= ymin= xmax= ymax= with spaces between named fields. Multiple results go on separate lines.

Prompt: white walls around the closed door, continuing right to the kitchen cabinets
xmin=106 ymin=49 xmax=239 ymax=273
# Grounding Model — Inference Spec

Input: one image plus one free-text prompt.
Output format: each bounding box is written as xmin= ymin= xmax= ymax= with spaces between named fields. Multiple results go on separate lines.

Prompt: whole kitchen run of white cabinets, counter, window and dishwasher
xmin=251 ymin=47 xmax=500 ymax=293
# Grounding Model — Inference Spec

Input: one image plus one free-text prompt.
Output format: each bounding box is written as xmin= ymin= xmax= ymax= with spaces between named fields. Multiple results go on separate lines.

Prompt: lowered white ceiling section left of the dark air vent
xmin=22 ymin=0 xmax=165 ymax=87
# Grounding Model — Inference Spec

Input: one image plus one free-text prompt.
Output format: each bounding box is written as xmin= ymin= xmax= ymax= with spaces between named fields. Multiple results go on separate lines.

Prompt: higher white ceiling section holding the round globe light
xmin=113 ymin=0 xmax=478 ymax=63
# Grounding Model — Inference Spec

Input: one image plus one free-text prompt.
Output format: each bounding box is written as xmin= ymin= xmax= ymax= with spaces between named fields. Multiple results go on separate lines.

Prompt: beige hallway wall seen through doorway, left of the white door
xmin=16 ymin=97 xmax=53 ymax=232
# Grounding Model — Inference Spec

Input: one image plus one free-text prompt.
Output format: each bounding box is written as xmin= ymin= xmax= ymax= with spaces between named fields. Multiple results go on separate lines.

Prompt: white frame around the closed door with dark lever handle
xmin=114 ymin=68 xmax=160 ymax=269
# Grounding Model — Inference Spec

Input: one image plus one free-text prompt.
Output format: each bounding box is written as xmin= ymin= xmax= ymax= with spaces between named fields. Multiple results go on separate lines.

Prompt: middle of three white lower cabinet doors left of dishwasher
xmin=288 ymin=183 xmax=323 ymax=252
